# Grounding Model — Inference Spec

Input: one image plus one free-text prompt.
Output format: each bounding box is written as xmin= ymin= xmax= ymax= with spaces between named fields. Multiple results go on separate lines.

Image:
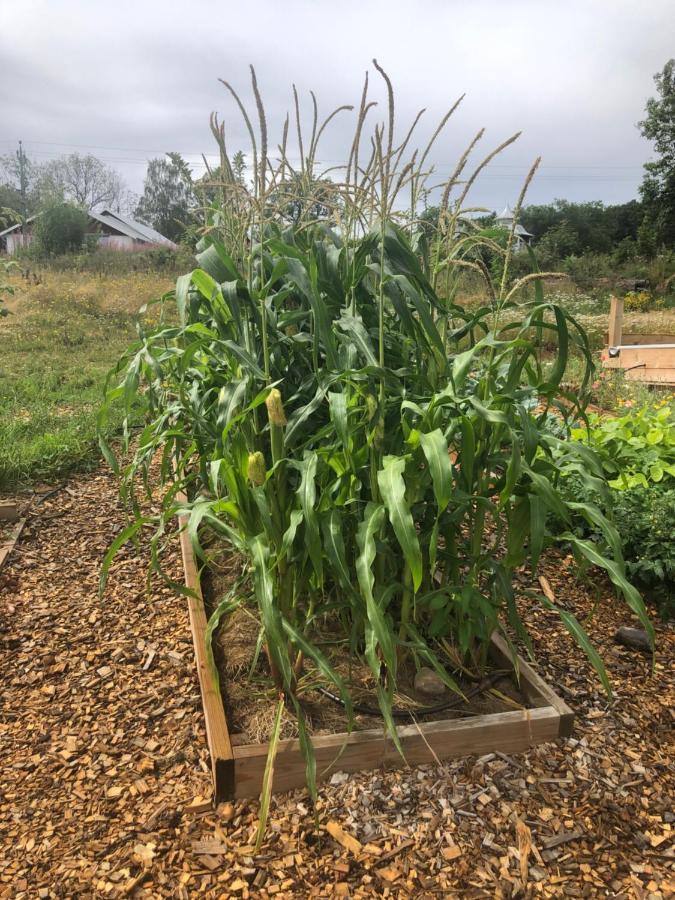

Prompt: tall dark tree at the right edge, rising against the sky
xmin=639 ymin=59 xmax=675 ymax=248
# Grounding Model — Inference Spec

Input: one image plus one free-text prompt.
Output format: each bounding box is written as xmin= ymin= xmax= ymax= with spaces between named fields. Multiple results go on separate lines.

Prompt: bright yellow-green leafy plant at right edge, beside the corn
xmin=571 ymin=405 xmax=675 ymax=491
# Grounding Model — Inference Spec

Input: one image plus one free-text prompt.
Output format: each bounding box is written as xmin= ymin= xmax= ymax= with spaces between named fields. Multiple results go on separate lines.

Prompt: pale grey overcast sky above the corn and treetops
xmin=0 ymin=0 xmax=675 ymax=209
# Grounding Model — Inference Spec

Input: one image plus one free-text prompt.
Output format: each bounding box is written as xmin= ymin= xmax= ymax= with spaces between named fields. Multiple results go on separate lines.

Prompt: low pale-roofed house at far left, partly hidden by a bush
xmin=0 ymin=209 xmax=176 ymax=255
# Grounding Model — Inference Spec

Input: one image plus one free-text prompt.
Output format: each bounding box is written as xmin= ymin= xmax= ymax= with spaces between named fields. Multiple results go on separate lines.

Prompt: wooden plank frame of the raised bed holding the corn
xmin=180 ymin=521 xmax=574 ymax=803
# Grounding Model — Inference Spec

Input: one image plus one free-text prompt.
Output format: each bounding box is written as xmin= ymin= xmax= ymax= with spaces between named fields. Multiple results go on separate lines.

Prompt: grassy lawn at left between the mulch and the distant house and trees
xmin=0 ymin=272 xmax=172 ymax=490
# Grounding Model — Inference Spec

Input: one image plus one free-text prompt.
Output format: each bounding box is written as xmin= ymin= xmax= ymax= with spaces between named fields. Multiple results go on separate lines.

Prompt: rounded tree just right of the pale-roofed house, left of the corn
xmin=135 ymin=153 xmax=196 ymax=241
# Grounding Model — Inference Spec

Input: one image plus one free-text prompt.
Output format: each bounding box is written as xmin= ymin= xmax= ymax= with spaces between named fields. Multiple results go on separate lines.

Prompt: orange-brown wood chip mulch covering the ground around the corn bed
xmin=0 ymin=473 xmax=675 ymax=900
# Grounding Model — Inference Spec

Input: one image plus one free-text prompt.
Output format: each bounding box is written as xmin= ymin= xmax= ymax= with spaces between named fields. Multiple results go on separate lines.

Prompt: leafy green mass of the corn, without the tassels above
xmin=110 ymin=225 xmax=652 ymax=710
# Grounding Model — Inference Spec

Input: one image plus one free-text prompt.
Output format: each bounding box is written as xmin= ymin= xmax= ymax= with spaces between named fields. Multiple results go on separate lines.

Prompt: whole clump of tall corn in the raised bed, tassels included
xmin=101 ymin=64 xmax=651 ymax=828
